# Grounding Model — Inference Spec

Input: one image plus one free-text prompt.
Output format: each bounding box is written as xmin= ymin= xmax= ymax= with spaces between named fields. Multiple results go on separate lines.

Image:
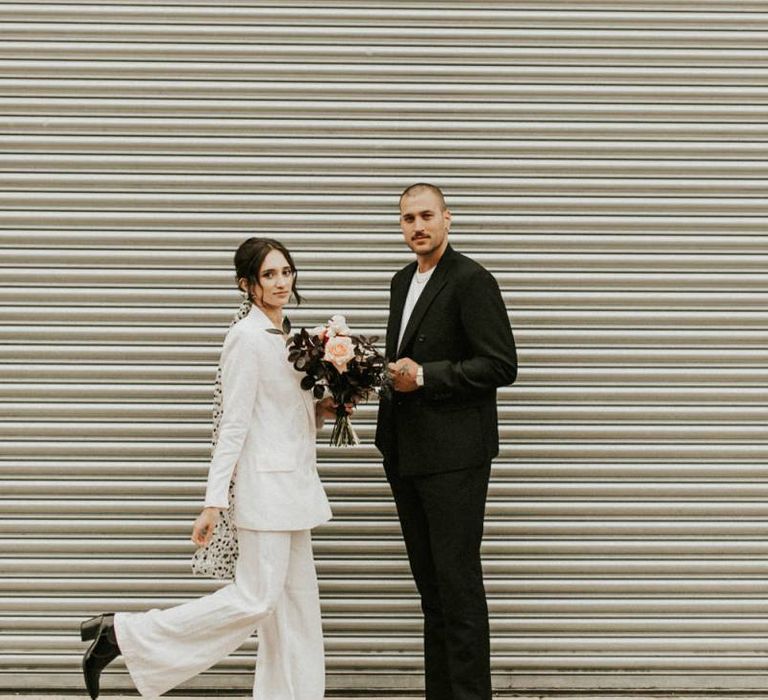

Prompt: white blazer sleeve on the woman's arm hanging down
xmin=205 ymin=326 xmax=258 ymax=508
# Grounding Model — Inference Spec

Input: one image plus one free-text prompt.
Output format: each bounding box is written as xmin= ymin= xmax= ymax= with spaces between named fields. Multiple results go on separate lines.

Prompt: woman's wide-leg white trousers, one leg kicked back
xmin=115 ymin=529 xmax=325 ymax=700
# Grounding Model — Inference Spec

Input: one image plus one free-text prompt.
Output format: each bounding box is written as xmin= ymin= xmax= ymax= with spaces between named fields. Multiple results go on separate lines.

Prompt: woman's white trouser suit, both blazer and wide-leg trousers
xmin=115 ymin=307 xmax=331 ymax=700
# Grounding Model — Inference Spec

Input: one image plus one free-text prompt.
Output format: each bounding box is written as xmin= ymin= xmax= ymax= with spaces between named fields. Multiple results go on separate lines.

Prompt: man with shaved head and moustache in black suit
xmin=376 ymin=183 xmax=517 ymax=700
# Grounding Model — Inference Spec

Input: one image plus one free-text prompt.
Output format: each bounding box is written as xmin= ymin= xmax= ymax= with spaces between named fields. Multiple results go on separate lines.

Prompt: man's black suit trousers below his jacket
xmin=386 ymin=464 xmax=491 ymax=700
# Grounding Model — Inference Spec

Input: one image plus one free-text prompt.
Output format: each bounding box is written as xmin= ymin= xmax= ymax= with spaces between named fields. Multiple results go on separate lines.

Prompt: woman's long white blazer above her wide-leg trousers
xmin=205 ymin=306 xmax=331 ymax=530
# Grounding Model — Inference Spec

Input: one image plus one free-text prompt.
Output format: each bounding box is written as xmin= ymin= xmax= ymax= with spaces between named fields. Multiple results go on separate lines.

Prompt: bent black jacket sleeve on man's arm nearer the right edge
xmin=423 ymin=268 xmax=517 ymax=401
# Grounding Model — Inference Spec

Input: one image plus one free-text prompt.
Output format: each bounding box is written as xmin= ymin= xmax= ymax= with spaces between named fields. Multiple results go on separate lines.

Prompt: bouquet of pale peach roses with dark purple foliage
xmin=288 ymin=316 xmax=388 ymax=447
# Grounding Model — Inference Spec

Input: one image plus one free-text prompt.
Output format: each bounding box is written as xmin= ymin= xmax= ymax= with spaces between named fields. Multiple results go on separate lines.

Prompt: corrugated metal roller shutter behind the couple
xmin=0 ymin=0 xmax=768 ymax=689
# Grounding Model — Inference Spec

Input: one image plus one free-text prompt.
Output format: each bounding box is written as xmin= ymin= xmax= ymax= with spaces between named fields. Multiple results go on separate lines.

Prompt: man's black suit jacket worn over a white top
xmin=376 ymin=246 xmax=517 ymax=476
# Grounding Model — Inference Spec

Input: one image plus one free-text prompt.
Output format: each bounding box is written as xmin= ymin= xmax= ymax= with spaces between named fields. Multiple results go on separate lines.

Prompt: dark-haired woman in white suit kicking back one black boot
xmin=81 ymin=238 xmax=340 ymax=700
